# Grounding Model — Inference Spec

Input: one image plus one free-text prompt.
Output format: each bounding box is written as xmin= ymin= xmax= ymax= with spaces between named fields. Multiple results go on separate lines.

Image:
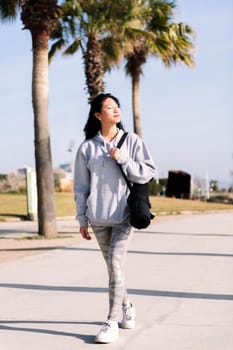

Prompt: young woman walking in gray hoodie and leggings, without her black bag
xmin=74 ymin=94 xmax=155 ymax=343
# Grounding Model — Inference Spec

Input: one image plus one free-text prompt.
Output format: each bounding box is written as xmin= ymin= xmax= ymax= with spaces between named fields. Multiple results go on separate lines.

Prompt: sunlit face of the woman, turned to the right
xmin=95 ymin=97 xmax=121 ymax=125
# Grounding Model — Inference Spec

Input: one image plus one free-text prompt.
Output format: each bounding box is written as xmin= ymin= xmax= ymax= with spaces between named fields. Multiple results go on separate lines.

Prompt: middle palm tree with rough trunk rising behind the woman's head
xmin=49 ymin=0 xmax=140 ymax=101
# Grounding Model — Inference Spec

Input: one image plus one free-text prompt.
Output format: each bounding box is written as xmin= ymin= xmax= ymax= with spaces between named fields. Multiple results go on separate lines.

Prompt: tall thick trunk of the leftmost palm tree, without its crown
xmin=31 ymin=31 xmax=57 ymax=238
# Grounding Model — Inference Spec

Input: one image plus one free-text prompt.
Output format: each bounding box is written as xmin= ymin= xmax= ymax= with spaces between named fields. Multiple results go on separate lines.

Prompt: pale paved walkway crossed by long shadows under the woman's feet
xmin=0 ymin=212 xmax=233 ymax=350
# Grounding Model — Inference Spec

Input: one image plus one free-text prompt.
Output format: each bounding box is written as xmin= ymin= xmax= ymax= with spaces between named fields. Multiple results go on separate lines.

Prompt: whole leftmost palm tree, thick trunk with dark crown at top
xmin=0 ymin=0 xmax=60 ymax=237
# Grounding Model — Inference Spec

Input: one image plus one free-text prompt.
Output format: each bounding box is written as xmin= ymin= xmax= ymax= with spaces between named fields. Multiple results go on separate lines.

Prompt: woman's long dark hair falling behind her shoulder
xmin=83 ymin=93 xmax=124 ymax=140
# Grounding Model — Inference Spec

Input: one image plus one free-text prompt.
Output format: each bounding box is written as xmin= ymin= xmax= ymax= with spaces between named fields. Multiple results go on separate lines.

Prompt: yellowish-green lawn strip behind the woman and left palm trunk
xmin=0 ymin=193 xmax=233 ymax=221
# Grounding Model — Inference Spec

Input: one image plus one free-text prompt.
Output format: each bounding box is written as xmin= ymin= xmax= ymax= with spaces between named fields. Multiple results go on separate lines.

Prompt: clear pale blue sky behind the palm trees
xmin=0 ymin=0 xmax=233 ymax=184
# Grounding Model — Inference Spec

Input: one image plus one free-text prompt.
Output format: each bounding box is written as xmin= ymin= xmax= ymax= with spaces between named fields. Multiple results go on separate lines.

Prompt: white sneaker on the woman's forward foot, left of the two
xmin=95 ymin=320 xmax=119 ymax=344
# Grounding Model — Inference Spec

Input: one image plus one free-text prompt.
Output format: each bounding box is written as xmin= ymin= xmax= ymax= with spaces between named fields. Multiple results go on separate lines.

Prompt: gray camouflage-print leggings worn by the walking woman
xmin=92 ymin=223 xmax=133 ymax=321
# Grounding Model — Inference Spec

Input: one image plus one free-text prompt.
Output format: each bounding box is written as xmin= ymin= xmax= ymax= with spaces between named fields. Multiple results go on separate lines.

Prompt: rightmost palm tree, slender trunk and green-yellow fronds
xmin=125 ymin=0 xmax=193 ymax=136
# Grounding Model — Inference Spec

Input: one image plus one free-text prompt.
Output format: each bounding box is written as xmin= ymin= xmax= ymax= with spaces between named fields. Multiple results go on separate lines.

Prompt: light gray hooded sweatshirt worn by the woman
xmin=74 ymin=130 xmax=155 ymax=226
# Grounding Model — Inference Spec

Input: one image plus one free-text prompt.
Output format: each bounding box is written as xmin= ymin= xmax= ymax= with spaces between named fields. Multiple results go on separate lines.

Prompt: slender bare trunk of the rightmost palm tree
xmin=132 ymin=73 xmax=142 ymax=137
